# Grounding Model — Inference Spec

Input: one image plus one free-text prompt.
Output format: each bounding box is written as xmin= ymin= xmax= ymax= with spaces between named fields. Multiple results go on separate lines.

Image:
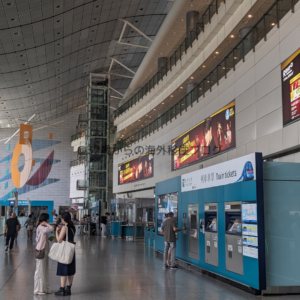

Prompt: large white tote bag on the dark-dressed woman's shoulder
xmin=48 ymin=226 xmax=75 ymax=265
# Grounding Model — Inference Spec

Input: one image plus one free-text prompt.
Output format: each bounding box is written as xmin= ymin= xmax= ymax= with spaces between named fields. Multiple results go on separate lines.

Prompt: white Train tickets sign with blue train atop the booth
xmin=181 ymin=153 xmax=256 ymax=192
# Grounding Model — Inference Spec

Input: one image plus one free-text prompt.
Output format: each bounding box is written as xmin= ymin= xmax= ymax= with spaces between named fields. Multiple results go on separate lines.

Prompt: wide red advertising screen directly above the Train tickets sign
xmin=172 ymin=101 xmax=235 ymax=171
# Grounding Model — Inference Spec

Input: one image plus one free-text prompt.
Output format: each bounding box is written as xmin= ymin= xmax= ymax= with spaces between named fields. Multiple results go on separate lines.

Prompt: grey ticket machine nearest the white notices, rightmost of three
xmin=225 ymin=201 xmax=244 ymax=275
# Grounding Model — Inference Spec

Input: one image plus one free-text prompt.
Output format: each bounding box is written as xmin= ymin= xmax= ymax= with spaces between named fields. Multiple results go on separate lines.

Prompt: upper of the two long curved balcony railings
xmin=114 ymin=0 xmax=225 ymax=118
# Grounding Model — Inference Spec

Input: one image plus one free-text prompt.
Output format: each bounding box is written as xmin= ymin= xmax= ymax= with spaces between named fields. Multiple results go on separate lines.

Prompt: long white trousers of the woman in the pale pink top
xmin=34 ymin=251 xmax=50 ymax=294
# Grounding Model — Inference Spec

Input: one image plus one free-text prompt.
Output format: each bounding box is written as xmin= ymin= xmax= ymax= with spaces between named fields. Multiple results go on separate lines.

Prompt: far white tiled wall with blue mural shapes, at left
xmin=0 ymin=108 xmax=84 ymax=212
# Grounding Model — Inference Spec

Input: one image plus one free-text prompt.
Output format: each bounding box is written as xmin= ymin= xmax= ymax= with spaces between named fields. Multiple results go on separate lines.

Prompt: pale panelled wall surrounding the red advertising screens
xmin=113 ymin=2 xmax=300 ymax=193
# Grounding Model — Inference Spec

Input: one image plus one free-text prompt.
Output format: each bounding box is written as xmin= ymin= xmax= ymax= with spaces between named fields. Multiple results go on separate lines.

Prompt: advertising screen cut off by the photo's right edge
xmin=281 ymin=50 xmax=300 ymax=126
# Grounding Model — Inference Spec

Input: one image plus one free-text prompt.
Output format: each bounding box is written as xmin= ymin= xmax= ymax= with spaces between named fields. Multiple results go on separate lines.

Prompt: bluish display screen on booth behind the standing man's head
xmin=157 ymin=193 xmax=178 ymax=235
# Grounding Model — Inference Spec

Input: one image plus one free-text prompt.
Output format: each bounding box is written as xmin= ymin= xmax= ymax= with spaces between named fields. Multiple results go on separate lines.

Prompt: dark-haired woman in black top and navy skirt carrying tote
xmin=55 ymin=212 xmax=76 ymax=296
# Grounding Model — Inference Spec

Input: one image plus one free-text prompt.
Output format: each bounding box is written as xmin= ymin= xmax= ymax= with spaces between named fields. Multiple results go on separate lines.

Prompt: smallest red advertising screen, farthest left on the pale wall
xmin=118 ymin=152 xmax=154 ymax=185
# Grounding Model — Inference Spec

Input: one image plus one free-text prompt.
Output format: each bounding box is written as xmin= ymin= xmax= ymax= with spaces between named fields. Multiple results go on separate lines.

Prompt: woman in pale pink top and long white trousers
xmin=34 ymin=213 xmax=53 ymax=295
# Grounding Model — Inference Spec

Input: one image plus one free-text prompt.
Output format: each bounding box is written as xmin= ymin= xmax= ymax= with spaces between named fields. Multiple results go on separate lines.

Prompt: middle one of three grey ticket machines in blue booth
xmin=204 ymin=203 xmax=219 ymax=267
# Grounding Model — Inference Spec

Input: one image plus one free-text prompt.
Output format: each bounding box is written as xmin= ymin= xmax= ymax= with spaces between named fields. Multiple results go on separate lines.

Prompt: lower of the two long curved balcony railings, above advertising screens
xmin=114 ymin=0 xmax=300 ymax=151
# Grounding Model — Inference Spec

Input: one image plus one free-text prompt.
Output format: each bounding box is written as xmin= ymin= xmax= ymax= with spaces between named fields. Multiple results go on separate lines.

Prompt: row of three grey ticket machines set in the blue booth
xmin=188 ymin=202 xmax=243 ymax=275
